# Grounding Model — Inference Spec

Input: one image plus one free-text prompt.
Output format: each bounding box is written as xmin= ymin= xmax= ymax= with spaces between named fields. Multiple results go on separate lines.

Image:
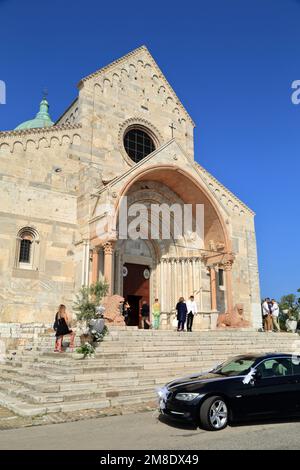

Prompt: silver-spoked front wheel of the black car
xmin=200 ymin=396 xmax=229 ymax=431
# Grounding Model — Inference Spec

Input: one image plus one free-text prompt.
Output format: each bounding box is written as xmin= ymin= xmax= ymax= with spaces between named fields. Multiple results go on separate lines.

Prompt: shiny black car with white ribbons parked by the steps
xmin=158 ymin=354 xmax=300 ymax=431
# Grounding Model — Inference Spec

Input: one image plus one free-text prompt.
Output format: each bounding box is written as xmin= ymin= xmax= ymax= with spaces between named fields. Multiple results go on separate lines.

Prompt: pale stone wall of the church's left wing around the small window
xmin=0 ymin=123 xmax=81 ymax=322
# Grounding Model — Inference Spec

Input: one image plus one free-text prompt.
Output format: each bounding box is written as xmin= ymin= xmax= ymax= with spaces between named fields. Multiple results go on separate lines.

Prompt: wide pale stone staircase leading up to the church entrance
xmin=0 ymin=327 xmax=300 ymax=416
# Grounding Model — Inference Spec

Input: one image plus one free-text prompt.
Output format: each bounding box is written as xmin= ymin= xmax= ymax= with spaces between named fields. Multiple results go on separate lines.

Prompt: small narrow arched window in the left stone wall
xmin=17 ymin=227 xmax=38 ymax=269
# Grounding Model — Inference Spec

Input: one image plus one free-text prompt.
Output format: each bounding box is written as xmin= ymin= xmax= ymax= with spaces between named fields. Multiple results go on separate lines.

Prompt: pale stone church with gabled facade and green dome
xmin=0 ymin=46 xmax=261 ymax=329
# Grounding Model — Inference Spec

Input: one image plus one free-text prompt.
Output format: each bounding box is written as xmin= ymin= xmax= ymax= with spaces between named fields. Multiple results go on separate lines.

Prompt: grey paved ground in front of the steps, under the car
xmin=0 ymin=412 xmax=300 ymax=450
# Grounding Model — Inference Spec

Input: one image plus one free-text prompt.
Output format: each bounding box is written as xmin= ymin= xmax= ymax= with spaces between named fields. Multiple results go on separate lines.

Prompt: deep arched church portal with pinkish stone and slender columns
xmin=90 ymin=165 xmax=233 ymax=326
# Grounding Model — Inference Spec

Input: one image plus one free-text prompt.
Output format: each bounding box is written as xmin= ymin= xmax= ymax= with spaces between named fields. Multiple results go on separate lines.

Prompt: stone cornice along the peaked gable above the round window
xmin=78 ymin=46 xmax=196 ymax=127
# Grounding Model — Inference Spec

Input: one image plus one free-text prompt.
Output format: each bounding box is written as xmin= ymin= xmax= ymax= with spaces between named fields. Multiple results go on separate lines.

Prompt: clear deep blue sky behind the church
xmin=0 ymin=0 xmax=300 ymax=297
